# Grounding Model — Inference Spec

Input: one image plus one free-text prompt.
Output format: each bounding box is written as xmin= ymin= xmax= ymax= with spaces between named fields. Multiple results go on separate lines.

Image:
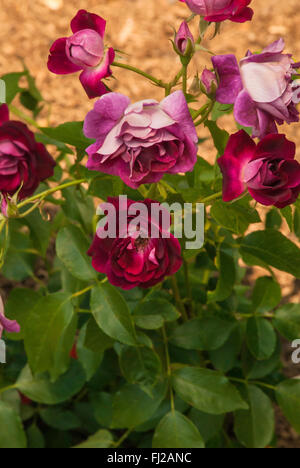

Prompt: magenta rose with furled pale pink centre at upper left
xmin=48 ymin=10 xmax=115 ymax=99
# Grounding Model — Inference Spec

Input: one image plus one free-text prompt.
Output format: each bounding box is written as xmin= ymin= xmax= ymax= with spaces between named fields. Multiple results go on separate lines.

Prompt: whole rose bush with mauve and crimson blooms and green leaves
xmin=0 ymin=0 xmax=300 ymax=450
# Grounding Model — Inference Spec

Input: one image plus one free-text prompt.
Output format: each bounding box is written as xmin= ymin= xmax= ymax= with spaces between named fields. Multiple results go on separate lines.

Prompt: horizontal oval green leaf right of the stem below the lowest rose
xmin=170 ymin=316 xmax=236 ymax=351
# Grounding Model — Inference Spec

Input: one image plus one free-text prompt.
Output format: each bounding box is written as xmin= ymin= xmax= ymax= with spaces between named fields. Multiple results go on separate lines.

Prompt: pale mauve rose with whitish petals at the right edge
xmin=212 ymin=39 xmax=300 ymax=138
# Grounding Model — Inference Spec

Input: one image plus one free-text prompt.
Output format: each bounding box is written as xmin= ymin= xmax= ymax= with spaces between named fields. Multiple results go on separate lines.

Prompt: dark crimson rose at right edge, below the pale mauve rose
xmin=218 ymin=130 xmax=300 ymax=208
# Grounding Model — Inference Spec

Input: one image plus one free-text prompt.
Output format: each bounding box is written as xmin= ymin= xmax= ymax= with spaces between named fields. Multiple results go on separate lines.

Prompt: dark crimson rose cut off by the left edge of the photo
xmin=0 ymin=104 xmax=55 ymax=203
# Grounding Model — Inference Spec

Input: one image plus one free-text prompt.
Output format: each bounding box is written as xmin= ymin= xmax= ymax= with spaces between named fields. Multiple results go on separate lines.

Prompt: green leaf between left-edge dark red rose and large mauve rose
xmin=40 ymin=122 xmax=93 ymax=150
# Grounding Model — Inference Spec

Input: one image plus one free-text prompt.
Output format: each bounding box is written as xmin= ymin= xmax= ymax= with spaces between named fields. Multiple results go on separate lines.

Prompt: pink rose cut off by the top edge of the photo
xmin=180 ymin=0 xmax=253 ymax=23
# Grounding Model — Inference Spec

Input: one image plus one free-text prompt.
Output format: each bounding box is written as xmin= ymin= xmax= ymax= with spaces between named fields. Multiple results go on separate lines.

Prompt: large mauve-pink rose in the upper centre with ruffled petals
xmin=84 ymin=91 xmax=198 ymax=189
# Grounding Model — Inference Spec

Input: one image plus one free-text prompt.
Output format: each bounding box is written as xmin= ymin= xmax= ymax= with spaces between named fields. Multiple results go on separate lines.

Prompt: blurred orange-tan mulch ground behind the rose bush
xmin=0 ymin=0 xmax=300 ymax=448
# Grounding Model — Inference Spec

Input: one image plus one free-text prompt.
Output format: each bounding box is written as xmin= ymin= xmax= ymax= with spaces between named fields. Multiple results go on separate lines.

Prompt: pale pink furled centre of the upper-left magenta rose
xmin=66 ymin=29 xmax=104 ymax=67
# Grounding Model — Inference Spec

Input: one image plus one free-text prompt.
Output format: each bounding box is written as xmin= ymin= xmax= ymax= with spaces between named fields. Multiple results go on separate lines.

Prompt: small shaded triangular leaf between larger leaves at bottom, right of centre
xmin=188 ymin=408 xmax=224 ymax=442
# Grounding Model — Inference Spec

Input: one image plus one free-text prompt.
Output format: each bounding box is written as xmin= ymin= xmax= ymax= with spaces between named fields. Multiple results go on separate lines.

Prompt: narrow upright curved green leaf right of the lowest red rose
xmin=207 ymin=243 xmax=236 ymax=303
